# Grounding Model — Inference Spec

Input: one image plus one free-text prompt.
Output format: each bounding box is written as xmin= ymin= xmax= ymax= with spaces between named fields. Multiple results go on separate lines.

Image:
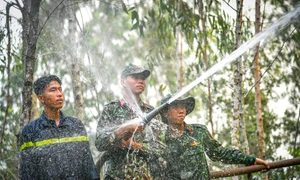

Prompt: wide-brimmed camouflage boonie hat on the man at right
xmin=160 ymin=94 xmax=195 ymax=123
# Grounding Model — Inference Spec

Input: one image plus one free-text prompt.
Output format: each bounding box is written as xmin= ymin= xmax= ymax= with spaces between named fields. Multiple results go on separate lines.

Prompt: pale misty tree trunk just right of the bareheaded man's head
xmin=66 ymin=0 xmax=84 ymax=121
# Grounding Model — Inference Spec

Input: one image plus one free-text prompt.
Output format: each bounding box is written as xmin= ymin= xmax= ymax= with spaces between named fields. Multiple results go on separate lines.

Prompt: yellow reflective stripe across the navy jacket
xmin=20 ymin=136 xmax=88 ymax=151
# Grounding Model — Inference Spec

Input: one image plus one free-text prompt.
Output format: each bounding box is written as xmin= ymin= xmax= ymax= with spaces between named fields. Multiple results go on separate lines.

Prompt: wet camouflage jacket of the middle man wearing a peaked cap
xmin=95 ymin=100 xmax=163 ymax=179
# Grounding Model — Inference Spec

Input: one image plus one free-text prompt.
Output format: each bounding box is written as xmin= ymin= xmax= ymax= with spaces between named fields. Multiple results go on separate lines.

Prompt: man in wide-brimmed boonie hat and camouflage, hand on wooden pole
xmin=161 ymin=95 xmax=268 ymax=180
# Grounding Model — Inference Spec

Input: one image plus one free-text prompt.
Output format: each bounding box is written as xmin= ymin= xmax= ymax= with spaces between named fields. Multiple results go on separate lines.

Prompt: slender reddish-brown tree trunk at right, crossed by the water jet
xmin=254 ymin=0 xmax=268 ymax=180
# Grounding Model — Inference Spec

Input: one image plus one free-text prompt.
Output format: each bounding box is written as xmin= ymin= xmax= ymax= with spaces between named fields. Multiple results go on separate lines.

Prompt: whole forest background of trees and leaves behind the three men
xmin=0 ymin=0 xmax=300 ymax=179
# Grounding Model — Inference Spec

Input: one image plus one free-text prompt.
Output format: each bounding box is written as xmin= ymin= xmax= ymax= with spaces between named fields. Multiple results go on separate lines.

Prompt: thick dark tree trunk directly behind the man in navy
xmin=17 ymin=0 xmax=41 ymax=177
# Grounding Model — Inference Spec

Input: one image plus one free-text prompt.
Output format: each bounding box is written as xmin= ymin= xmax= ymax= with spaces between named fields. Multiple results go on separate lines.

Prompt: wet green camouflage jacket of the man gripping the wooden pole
xmin=164 ymin=124 xmax=255 ymax=180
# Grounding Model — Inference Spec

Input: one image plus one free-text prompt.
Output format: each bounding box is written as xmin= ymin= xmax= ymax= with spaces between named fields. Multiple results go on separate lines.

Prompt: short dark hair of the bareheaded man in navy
xmin=33 ymin=75 xmax=61 ymax=96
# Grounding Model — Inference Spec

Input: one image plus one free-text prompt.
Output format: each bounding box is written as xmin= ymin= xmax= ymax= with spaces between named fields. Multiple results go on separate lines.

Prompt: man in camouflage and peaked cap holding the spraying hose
xmin=95 ymin=64 xmax=163 ymax=179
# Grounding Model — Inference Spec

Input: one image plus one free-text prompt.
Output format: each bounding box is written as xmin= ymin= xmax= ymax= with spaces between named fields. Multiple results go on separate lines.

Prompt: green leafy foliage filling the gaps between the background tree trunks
xmin=0 ymin=0 xmax=300 ymax=179
